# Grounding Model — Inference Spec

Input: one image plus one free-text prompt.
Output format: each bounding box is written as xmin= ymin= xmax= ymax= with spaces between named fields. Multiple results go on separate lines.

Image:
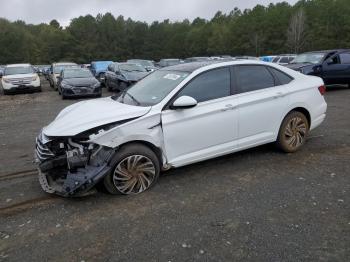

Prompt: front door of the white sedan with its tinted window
xmin=162 ymin=67 xmax=238 ymax=167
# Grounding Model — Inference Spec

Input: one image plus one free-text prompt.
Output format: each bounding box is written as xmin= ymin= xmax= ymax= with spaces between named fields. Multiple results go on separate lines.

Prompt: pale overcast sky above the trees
xmin=0 ymin=0 xmax=297 ymax=26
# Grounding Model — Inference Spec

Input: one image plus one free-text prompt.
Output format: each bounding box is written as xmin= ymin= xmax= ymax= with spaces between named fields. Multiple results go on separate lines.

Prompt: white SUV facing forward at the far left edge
xmin=1 ymin=64 xmax=41 ymax=95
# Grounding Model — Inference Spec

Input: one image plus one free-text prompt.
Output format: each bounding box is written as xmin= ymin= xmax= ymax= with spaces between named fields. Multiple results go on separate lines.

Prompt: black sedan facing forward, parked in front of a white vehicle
xmin=57 ymin=68 xmax=102 ymax=99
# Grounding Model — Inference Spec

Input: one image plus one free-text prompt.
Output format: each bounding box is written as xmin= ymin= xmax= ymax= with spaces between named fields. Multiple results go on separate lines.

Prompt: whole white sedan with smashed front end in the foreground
xmin=35 ymin=60 xmax=327 ymax=196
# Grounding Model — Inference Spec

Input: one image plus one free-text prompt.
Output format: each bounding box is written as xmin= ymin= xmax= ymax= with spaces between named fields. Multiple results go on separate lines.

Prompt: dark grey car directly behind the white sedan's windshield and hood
xmin=105 ymin=63 xmax=150 ymax=91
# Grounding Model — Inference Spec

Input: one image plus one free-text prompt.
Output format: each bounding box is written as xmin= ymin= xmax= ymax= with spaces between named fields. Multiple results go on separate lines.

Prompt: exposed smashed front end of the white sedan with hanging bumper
xmin=35 ymin=133 xmax=115 ymax=196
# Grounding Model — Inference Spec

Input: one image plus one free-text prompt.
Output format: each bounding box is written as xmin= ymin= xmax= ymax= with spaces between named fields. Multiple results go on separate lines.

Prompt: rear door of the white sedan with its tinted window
xmin=235 ymin=65 xmax=293 ymax=148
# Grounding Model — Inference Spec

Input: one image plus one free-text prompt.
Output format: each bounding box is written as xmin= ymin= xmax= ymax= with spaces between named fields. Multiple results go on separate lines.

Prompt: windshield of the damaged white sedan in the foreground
xmin=113 ymin=71 xmax=189 ymax=106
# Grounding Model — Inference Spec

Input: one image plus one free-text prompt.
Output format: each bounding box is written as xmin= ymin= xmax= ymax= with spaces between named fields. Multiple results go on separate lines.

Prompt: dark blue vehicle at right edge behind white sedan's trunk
xmin=287 ymin=49 xmax=350 ymax=87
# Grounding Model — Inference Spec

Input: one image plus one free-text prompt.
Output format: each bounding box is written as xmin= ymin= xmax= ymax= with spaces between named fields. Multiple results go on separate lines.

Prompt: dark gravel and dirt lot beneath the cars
xmin=0 ymin=78 xmax=350 ymax=262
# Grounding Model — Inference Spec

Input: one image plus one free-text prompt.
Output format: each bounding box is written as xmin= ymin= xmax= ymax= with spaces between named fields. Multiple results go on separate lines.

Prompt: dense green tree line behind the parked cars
xmin=0 ymin=0 xmax=350 ymax=64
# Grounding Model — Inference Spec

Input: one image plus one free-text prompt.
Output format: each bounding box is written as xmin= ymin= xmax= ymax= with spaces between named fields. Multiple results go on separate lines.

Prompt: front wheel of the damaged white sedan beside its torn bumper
xmin=103 ymin=143 xmax=160 ymax=195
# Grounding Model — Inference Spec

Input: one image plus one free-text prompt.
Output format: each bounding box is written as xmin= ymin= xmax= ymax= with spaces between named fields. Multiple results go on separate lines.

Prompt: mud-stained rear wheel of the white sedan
xmin=276 ymin=111 xmax=309 ymax=153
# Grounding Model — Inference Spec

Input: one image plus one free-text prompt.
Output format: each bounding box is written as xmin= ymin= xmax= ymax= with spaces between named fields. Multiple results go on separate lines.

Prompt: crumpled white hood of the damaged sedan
xmin=43 ymin=97 xmax=151 ymax=137
